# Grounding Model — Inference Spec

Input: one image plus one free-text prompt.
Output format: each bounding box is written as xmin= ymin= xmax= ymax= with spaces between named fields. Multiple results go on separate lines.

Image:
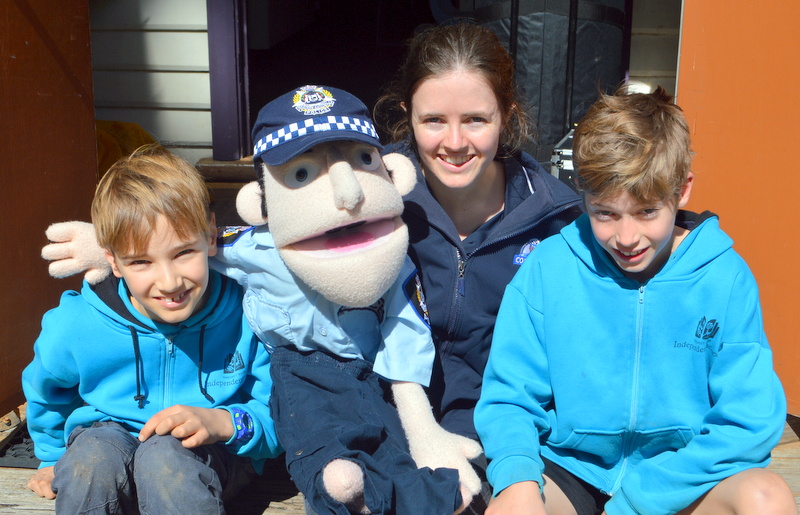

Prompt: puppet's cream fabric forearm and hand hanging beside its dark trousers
xmin=392 ymin=382 xmax=483 ymax=504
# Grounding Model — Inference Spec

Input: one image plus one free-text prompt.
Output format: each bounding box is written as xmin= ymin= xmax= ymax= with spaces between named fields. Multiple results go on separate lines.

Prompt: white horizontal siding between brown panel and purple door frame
xmin=89 ymin=0 xmax=212 ymax=163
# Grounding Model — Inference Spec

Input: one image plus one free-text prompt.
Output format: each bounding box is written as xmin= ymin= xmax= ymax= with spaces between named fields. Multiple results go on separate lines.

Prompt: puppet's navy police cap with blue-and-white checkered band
xmin=253 ymin=86 xmax=383 ymax=166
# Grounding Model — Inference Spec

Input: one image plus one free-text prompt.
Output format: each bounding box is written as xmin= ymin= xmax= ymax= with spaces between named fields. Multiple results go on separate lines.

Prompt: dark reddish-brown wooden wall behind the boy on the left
xmin=0 ymin=0 xmax=102 ymax=416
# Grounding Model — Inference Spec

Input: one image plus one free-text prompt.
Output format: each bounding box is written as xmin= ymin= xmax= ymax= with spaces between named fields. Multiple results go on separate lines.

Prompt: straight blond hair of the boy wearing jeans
xmin=92 ymin=144 xmax=212 ymax=254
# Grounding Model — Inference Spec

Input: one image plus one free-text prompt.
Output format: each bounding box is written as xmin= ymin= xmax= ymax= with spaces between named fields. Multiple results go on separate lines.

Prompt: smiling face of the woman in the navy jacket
xmin=410 ymin=70 xmax=503 ymax=195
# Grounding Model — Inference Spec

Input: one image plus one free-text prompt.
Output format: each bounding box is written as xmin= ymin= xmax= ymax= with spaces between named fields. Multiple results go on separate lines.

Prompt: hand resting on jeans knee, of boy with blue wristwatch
xmin=139 ymin=404 xmax=233 ymax=449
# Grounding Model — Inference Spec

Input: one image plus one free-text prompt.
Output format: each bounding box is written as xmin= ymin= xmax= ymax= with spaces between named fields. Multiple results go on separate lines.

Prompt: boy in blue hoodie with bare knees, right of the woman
xmin=475 ymin=87 xmax=797 ymax=515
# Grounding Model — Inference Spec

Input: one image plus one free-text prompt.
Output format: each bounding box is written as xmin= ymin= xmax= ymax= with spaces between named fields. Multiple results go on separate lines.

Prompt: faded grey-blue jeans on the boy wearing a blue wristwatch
xmin=52 ymin=422 xmax=255 ymax=515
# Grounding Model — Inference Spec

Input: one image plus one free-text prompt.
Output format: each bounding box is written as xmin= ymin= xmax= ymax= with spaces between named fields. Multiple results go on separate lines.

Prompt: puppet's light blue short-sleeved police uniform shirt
xmin=210 ymin=226 xmax=434 ymax=386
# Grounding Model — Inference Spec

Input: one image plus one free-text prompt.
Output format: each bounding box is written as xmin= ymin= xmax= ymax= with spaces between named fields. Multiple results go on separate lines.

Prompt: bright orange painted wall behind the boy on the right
xmin=677 ymin=0 xmax=800 ymax=415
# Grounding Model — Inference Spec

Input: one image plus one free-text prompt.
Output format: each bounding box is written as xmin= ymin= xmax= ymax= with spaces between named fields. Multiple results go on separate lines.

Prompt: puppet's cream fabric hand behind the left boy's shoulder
xmin=42 ymin=222 xmax=111 ymax=284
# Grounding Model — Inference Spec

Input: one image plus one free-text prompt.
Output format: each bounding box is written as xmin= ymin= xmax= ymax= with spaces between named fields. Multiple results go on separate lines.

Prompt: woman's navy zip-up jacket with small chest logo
xmin=386 ymin=141 xmax=581 ymax=439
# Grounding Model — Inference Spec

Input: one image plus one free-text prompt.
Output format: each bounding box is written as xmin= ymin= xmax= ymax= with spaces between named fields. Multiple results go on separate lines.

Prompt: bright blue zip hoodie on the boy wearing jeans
xmin=22 ymin=271 xmax=281 ymax=471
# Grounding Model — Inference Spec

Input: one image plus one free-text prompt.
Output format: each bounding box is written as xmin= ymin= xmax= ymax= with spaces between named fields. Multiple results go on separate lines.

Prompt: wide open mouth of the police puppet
xmin=289 ymin=218 xmax=395 ymax=258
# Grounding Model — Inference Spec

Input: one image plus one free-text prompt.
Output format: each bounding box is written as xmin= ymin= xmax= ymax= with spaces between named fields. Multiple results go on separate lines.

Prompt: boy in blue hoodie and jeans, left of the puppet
xmin=22 ymin=146 xmax=281 ymax=514
